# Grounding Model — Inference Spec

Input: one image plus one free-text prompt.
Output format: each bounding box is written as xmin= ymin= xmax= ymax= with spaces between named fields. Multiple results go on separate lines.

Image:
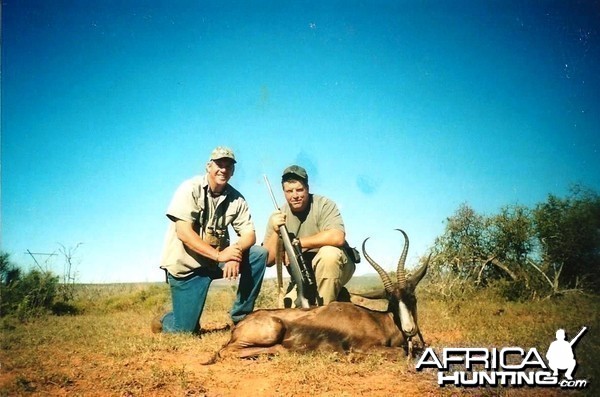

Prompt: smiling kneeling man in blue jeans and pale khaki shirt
xmin=152 ymin=146 xmax=267 ymax=332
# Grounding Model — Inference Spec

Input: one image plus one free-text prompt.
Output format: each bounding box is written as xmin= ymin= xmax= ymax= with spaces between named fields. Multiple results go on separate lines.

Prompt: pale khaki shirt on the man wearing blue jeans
xmin=160 ymin=175 xmax=254 ymax=277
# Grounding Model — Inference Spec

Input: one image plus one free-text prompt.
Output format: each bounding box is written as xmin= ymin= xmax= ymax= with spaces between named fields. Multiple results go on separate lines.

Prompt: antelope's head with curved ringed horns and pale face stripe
xmin=362 ymin=229 xmax=431 ymax=345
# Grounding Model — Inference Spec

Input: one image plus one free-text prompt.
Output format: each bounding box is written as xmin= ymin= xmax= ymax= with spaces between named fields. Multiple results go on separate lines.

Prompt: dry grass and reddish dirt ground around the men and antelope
xmin=0 ymin=276 xmax=600 ymax=396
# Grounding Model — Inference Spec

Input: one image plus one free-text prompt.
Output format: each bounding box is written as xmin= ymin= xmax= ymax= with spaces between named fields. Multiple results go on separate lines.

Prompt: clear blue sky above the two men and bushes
xmin=2 ymin=0 xmax=600 ymax=282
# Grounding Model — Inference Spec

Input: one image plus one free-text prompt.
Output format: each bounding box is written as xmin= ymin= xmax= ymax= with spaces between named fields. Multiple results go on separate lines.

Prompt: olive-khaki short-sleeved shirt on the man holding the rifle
xmin=265 ymin=194 xmax=345 ymax=252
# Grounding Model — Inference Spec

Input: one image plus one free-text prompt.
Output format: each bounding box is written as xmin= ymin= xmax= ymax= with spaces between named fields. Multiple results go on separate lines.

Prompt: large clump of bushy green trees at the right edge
xmin=430 ymin=186 xmax=600 ymax=299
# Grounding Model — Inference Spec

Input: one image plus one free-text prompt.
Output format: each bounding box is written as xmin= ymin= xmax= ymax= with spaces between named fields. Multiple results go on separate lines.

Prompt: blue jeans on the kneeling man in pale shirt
xmin=162 ymin=245 xmax=267 ymax=332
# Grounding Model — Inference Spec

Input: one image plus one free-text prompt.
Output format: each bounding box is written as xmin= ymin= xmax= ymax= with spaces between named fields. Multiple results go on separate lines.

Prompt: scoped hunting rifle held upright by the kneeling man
xmin=263 ymin=175 xmax=320 ymax=308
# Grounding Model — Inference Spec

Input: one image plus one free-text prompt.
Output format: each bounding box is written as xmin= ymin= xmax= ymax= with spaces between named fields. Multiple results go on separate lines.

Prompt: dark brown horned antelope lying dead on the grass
xmin=211 ymin=229 xmax=429 ymax=362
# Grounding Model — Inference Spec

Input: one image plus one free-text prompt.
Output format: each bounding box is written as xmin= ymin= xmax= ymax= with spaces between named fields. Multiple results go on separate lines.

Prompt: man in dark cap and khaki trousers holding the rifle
xmin=263 ymin=165 xmax=359 ymax=306
